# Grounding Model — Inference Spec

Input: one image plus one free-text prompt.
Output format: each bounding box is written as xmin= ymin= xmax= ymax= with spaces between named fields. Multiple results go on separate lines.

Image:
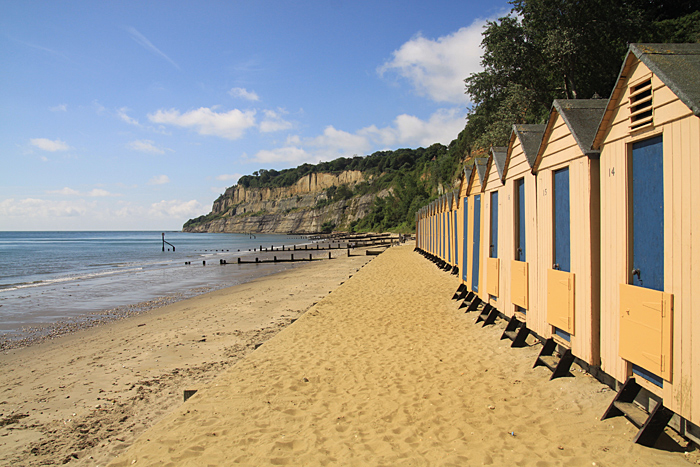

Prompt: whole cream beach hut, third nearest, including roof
xmin=501 ymin=125 xmax=551 ymax=336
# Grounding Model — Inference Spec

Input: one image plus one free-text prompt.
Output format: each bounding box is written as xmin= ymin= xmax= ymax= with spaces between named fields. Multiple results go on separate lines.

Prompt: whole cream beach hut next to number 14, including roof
xmin=534 ymin=99 xmax=606 ymax=365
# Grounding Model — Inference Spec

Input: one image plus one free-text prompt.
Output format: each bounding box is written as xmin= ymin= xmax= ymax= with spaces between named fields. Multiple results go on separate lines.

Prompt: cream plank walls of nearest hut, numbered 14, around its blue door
xmin=599 ymin=50 xmax=700 ymax=425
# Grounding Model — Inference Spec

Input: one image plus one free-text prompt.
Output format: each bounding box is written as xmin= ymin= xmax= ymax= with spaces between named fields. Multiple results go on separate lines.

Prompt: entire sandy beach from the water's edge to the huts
xmin=0 ymin=245 xmax=700 ymax=466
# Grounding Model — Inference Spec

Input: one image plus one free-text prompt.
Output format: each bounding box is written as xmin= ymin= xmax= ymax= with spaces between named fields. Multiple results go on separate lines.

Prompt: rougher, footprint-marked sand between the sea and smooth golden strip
xmin=0 ymin=250 xmax=371 ymax=466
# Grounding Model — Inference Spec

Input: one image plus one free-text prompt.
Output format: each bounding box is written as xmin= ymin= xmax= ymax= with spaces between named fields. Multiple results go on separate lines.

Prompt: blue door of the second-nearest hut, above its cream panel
xmin=554 ymin=167 xmax=571 ymax=272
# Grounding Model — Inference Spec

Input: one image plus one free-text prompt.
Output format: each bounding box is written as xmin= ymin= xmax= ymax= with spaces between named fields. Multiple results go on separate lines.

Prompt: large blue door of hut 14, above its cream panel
xmin=630 ymin=136 xmax=664 ymax=291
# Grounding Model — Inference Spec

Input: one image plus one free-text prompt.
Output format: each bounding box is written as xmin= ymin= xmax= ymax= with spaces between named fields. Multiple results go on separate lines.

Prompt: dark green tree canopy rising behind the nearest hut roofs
xmin=465 ymin=0 xmax=700 ymax=150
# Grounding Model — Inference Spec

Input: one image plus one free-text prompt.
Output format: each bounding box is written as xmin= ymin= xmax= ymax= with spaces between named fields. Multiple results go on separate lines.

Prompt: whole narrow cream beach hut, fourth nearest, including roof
xmin=480 ymin=147 xmax=506 ymax=310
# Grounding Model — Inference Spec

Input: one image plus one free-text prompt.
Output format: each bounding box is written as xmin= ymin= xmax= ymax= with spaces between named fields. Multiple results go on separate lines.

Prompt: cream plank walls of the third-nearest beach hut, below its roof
xmin=502 ymin=132 xmax=551 ymax=337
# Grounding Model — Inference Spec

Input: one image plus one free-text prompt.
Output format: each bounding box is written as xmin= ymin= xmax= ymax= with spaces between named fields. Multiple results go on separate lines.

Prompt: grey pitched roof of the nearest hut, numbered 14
xmin=593 ymin=43 xmax=700 ymax=148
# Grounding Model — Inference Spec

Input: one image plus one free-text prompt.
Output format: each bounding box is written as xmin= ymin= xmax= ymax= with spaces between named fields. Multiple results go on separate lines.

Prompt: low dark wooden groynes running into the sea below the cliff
xmin=185 ymin=234 xmax=406 ymax=266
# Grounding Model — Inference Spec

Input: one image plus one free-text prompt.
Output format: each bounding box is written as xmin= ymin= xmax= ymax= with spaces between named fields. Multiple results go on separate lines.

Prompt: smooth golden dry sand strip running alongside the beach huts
xmin=101 ymin=246 xmax=699 ymax=467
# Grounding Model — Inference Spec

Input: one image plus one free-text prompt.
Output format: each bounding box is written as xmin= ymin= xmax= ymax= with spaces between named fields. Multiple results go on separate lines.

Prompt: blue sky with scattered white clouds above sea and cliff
xmin=0 ymin=0 xmax=509 ymax=230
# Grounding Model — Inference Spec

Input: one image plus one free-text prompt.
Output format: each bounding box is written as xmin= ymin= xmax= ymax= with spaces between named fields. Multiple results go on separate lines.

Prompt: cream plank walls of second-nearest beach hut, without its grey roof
xmin=535 ymin=110 xmax=600 ymax=365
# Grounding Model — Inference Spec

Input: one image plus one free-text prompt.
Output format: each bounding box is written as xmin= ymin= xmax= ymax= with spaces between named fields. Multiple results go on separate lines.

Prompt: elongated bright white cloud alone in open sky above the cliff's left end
xmin=148 ymin=107 xmax=255 ymax=140
